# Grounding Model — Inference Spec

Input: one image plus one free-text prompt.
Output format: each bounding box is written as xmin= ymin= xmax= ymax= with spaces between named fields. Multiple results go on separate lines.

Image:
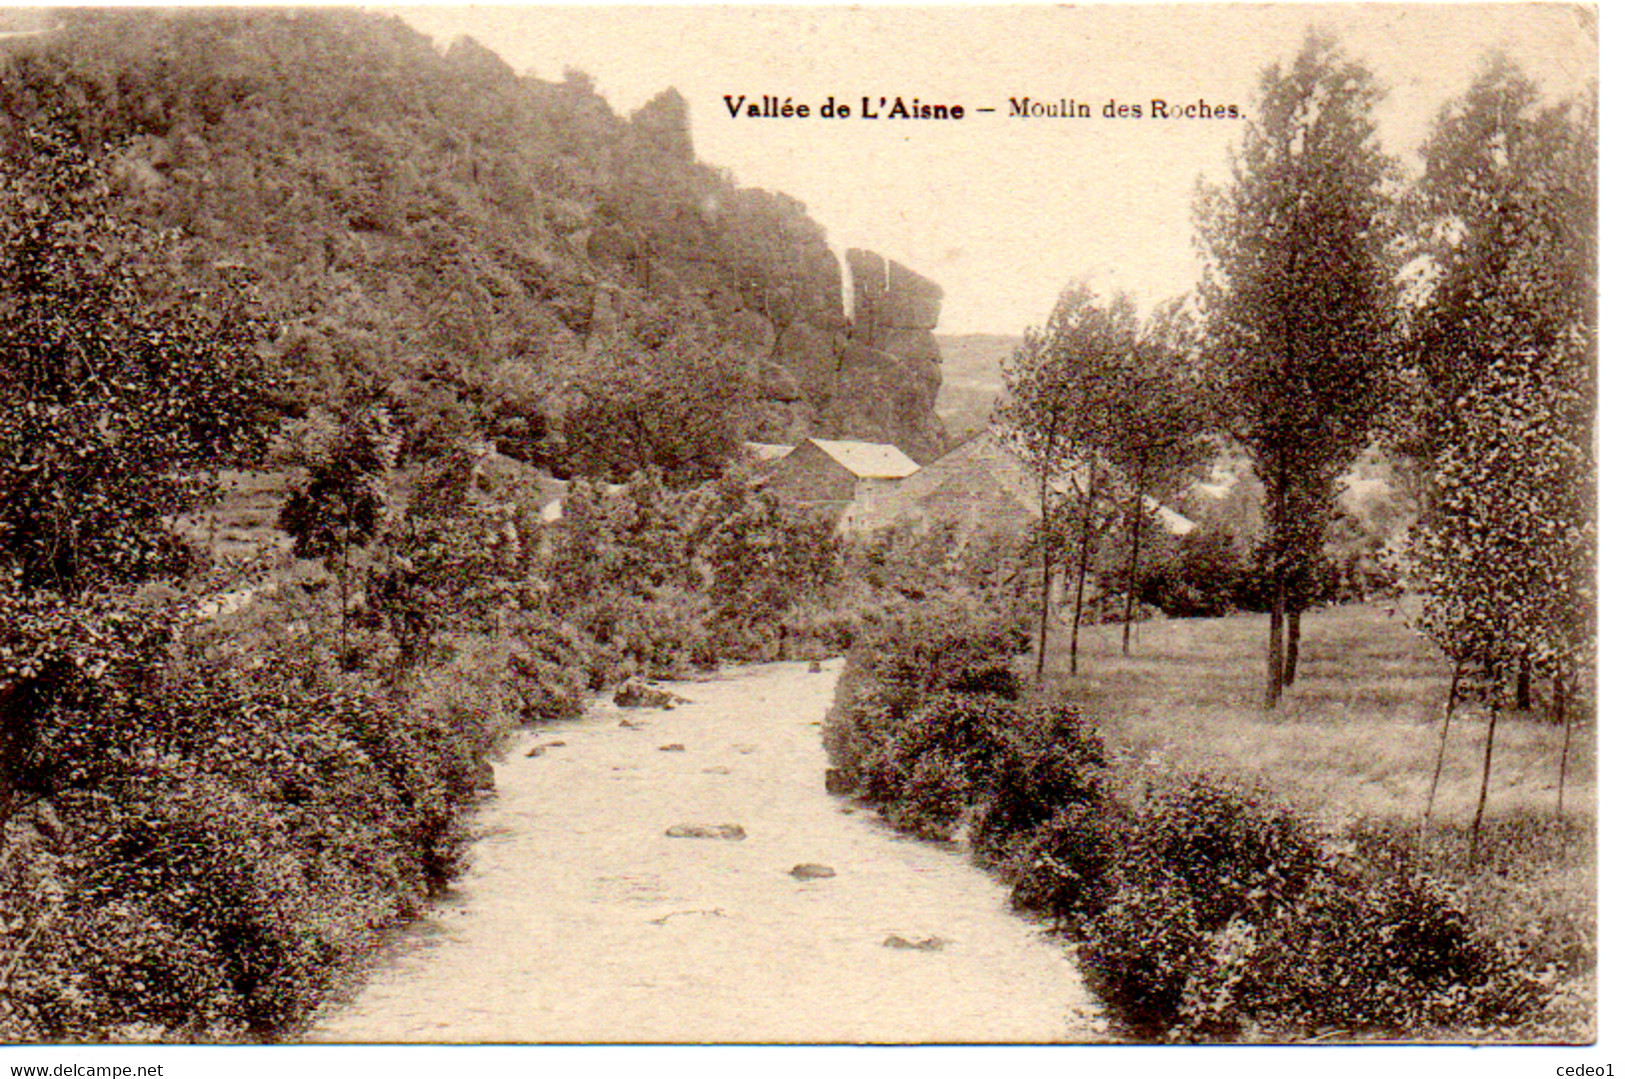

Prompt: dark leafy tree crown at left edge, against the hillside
xmin=0 ymin=127 xmax=268 ymax=595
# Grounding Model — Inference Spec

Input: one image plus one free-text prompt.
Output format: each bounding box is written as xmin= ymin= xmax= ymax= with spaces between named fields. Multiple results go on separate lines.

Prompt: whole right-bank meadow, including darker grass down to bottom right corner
xmin=1047 ymin=605 xmax=1597 ymax=1042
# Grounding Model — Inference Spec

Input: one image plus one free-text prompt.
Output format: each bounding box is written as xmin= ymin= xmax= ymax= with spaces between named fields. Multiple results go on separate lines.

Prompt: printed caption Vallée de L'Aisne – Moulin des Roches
xmin=722 ymin=94 xmax=1242 ymax=120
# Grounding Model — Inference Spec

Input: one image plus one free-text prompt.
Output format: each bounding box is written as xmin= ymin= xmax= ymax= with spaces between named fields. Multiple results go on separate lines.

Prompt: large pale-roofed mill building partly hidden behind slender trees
xmin=868 ymin=431 xmax=1196 ymax=536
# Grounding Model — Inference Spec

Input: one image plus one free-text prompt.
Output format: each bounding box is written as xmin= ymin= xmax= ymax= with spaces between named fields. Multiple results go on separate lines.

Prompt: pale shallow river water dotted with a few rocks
xmin=309 ymin=663 xmax=1099 ymax=1043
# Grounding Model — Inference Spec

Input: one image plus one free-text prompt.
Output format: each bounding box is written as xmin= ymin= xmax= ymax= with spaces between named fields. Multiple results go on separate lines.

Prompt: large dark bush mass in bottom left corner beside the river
xmin=0 ymin=594 xmax=501 ymax=1042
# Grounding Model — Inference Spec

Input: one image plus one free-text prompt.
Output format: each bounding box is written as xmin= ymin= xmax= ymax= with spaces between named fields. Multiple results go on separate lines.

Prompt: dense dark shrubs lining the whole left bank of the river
xmin=0 ymin=462 xmax=949 ymax=1042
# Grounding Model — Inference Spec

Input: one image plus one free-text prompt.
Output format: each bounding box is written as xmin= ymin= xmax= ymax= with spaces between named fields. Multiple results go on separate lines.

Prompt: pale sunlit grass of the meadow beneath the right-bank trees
xmin=1048 ymin=605 xmax=1596 ymax=827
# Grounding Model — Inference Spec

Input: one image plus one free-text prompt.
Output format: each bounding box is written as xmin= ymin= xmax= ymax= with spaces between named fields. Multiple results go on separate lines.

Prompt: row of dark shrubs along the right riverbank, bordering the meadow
xmin=826 ymin=596 xmax=1583 ymax=1042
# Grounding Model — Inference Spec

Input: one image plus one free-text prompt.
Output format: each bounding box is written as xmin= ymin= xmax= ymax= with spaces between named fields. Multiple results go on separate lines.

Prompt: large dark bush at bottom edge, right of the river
xmin=1079 ymin=777 xmax=1528 ymax=1040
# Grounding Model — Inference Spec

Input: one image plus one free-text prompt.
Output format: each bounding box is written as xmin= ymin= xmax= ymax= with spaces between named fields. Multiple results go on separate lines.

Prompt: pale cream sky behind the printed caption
xmin=387 ymin=3 xmax=1597 ymax=333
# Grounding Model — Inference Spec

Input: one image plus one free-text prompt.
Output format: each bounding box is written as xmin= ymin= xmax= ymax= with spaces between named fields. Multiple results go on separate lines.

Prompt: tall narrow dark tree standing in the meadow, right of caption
xmin=1198 ymin=34 xmax=1396 ymax=707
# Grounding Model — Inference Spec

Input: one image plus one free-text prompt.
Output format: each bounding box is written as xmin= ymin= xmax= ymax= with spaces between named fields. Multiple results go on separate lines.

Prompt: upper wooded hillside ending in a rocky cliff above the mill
xmin=0 ymin=10 xmax=943 ymax=466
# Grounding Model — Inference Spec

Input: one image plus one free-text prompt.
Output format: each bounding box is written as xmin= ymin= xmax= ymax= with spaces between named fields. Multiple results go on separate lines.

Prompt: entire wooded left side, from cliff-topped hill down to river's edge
xmin=0 ymin=10 xmax=962 ymax=1042
